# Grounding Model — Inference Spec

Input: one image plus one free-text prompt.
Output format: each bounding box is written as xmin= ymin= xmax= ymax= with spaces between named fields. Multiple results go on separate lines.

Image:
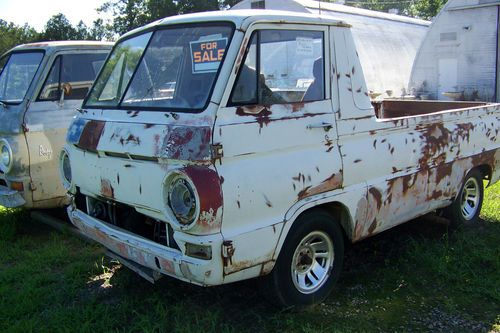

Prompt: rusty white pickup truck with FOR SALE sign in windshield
xmin=60 ymin=10 xmax=500 ymax=305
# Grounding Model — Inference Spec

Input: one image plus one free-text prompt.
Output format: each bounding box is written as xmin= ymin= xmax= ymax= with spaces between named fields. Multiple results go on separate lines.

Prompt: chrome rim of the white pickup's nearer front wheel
xmin=291 ymin=231 xmax=335 ymax=294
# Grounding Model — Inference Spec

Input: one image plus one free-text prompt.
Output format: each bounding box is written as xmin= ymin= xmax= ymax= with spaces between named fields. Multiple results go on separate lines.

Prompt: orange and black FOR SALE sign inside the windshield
xmin=190 ymin=38 xmax=227 ymax=74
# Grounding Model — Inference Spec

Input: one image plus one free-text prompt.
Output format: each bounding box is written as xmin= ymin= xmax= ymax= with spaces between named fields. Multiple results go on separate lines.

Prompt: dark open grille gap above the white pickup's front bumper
xmin=75 ymin=191 xmax=180 ymax=250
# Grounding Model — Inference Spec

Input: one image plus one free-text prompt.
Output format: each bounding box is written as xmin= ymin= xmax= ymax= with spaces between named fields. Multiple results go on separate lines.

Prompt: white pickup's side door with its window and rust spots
xmin=214 ymin=25 xmax=342 ymax=239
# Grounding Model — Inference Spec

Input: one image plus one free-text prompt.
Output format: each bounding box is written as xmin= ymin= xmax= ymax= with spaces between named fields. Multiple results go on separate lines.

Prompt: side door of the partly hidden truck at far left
xmin=25 ymin=51 xmax=106 ymax=201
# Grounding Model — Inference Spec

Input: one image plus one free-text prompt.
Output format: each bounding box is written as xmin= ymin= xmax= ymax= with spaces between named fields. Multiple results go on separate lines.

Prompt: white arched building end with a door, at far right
xmin=410 ymin=0 xmax=500 ymax=101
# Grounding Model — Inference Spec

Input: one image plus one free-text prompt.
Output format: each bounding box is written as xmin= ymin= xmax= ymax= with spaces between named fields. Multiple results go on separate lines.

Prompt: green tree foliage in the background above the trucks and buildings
xmin=0 ymin=0 xmax=446 ymax=53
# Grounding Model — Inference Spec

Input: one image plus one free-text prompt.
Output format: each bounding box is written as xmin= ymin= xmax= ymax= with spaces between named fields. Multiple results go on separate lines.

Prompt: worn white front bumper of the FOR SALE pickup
xmin=68 ymin=206 xmax=223 ymax=286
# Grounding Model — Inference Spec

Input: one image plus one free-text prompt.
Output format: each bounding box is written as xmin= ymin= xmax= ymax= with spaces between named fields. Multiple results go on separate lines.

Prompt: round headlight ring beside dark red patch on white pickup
xmin=163 ymin=171 xmax=200 ymax=230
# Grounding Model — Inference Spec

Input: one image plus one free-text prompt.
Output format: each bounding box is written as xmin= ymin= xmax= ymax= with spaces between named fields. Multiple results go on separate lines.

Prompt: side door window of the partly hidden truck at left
xmin=38 ymin=53 xmax=106 ymax=101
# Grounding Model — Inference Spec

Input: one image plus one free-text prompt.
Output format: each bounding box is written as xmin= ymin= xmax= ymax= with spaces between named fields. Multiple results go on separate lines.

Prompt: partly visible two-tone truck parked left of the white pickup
xmin=0 ymin=42 xmax=112 ymax=209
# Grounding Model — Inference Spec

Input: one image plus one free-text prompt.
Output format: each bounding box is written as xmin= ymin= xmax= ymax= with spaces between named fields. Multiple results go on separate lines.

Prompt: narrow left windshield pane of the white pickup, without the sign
xmin=86 ymin=32 xmax=152 ymax=106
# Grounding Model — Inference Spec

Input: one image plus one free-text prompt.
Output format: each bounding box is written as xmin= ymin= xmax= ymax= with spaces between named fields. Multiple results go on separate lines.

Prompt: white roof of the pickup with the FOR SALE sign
xmin=120 ymin=9 xmax=346 ymax=39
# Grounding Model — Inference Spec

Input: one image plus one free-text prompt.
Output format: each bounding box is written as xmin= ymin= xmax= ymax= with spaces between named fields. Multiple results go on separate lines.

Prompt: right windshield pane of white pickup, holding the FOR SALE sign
xmin=122 ymin=26 xmax=232 ymax=109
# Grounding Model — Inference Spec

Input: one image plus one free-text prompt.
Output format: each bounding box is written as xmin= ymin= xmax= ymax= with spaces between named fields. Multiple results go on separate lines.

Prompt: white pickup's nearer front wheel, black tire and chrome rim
xmin=262 ymin=211 xmax=344 ymax=306
